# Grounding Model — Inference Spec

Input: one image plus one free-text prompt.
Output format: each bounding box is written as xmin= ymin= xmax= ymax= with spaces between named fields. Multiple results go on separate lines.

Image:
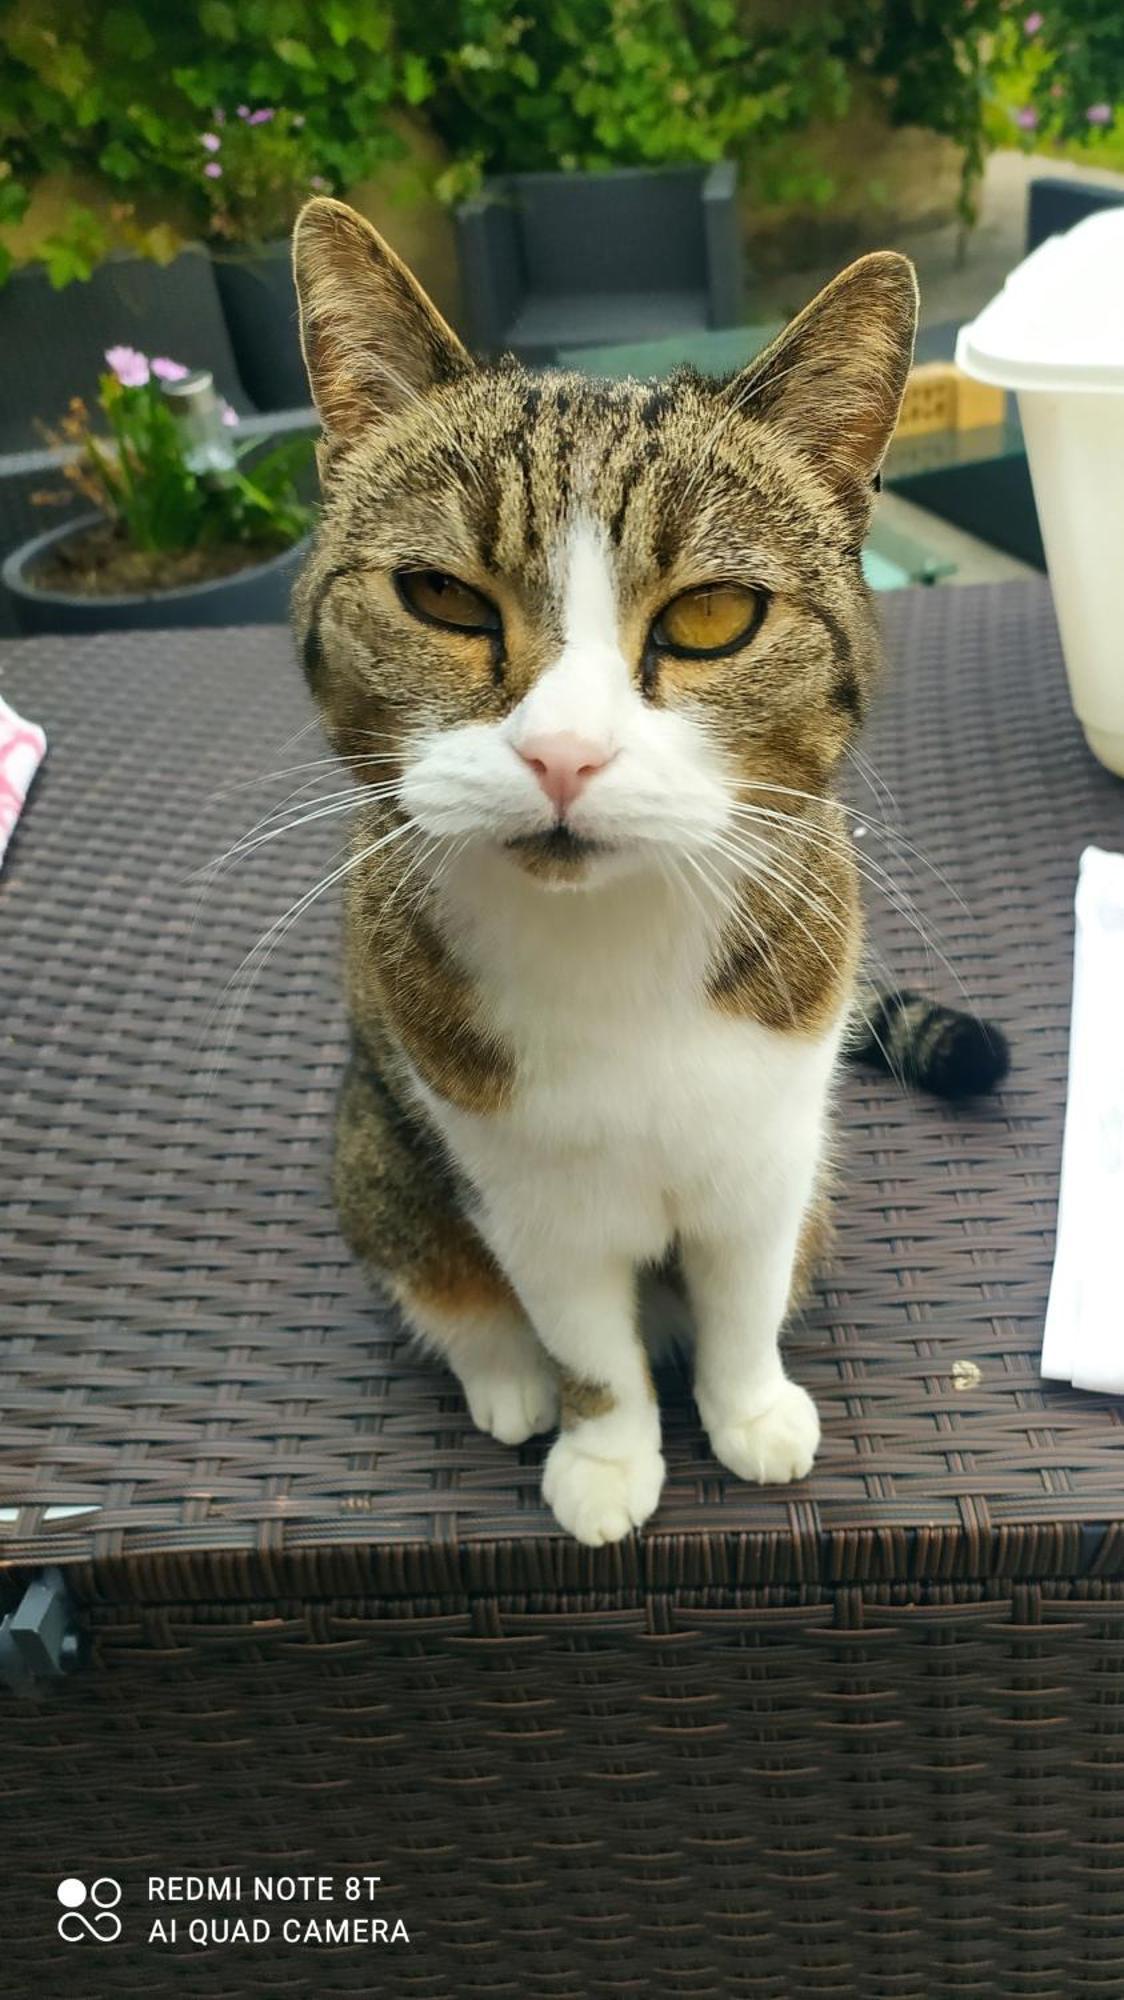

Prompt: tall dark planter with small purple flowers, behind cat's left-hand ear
xmin=198 ymin=104 xmax=330 ymax=410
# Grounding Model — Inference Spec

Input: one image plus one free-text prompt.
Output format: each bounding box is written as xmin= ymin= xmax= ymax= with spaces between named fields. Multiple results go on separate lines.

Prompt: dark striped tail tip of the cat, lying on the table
xmin=844 ymin=986 xmax=1010 ymax=1098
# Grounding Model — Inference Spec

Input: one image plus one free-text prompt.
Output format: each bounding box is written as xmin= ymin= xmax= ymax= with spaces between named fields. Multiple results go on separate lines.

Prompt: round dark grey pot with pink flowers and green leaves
xmin=2 ymin=346 xmax=312 ymax=634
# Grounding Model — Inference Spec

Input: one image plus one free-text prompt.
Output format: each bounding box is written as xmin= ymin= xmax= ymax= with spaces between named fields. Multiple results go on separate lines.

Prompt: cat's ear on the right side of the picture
xmin=722 ymin=250 xmax=918 ymax=494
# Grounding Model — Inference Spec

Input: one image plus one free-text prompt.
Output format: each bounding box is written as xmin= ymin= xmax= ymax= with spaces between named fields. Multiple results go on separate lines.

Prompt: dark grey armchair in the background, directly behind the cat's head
xmin=456 ymin=160 xmax=742 ymax=362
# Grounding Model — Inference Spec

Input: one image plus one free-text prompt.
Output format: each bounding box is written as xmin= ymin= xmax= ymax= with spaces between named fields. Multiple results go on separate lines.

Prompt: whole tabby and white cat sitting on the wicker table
xmin=294 ymin=200 xmax=1000 ymax=1544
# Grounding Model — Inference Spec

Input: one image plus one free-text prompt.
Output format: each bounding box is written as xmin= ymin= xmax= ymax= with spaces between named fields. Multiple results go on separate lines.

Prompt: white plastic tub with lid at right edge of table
xmin=956 ymin=208 xmax=1124 ymax=776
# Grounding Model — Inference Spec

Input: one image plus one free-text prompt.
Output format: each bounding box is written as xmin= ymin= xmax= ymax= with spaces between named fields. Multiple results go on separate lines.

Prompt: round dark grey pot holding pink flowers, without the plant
xmin=2 ymin=514 xmax=308 ymax=638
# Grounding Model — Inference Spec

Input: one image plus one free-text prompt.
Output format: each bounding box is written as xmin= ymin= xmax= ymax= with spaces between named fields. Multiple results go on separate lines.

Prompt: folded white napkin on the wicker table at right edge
xmin=1042 ymin=848 xmax=1124 ymax=1396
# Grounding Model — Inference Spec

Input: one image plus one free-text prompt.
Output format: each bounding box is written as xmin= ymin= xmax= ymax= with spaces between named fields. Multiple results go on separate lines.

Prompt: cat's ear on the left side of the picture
xmin=292 ymin=196 xmax=472 ymax=444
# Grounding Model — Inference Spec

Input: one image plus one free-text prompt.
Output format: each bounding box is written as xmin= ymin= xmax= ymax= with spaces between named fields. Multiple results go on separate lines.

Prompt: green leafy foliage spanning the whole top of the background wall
xmin=0 ymin=0 xmax=1124 ymax=284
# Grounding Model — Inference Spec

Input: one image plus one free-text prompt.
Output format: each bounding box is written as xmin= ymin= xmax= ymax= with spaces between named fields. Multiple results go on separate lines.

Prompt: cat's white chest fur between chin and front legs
xmin=414 ymin=848 xmax=838 ymax=1260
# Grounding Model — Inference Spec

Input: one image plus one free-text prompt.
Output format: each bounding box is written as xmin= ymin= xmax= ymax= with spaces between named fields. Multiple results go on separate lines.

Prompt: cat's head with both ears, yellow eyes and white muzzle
xmin=294 ymin=200 xmax=916 ymax=884
